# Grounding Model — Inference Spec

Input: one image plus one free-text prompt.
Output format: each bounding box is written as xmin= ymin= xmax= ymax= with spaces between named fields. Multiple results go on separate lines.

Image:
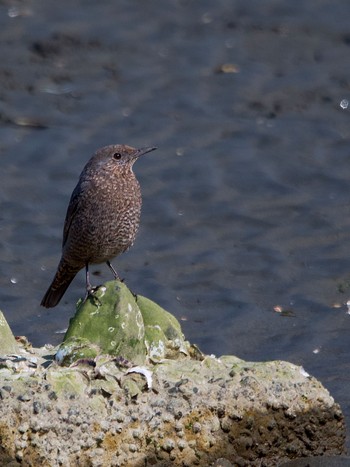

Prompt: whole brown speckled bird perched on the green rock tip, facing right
xmin=41 ymin=144 xmax=157 ymax=308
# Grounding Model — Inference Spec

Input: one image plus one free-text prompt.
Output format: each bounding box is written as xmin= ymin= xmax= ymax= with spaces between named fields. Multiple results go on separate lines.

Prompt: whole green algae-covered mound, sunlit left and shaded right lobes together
xmin=56 ymin=281 xmax=190 ymax=365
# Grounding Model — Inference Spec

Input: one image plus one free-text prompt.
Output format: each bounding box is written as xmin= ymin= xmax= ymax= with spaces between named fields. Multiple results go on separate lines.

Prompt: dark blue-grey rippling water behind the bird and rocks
xmin=0 ymin=0 xmax=350 ymax=448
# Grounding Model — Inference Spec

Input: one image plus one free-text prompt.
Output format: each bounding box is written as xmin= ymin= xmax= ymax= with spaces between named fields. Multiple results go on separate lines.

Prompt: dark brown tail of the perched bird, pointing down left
xmin=41 ymin=260 xmax=81 ymax=308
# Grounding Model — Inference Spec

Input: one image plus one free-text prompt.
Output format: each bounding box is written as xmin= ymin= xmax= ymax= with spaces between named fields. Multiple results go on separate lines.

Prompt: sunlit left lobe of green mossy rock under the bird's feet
xmin=56 ymin=281 xmax=147 ymax=365
